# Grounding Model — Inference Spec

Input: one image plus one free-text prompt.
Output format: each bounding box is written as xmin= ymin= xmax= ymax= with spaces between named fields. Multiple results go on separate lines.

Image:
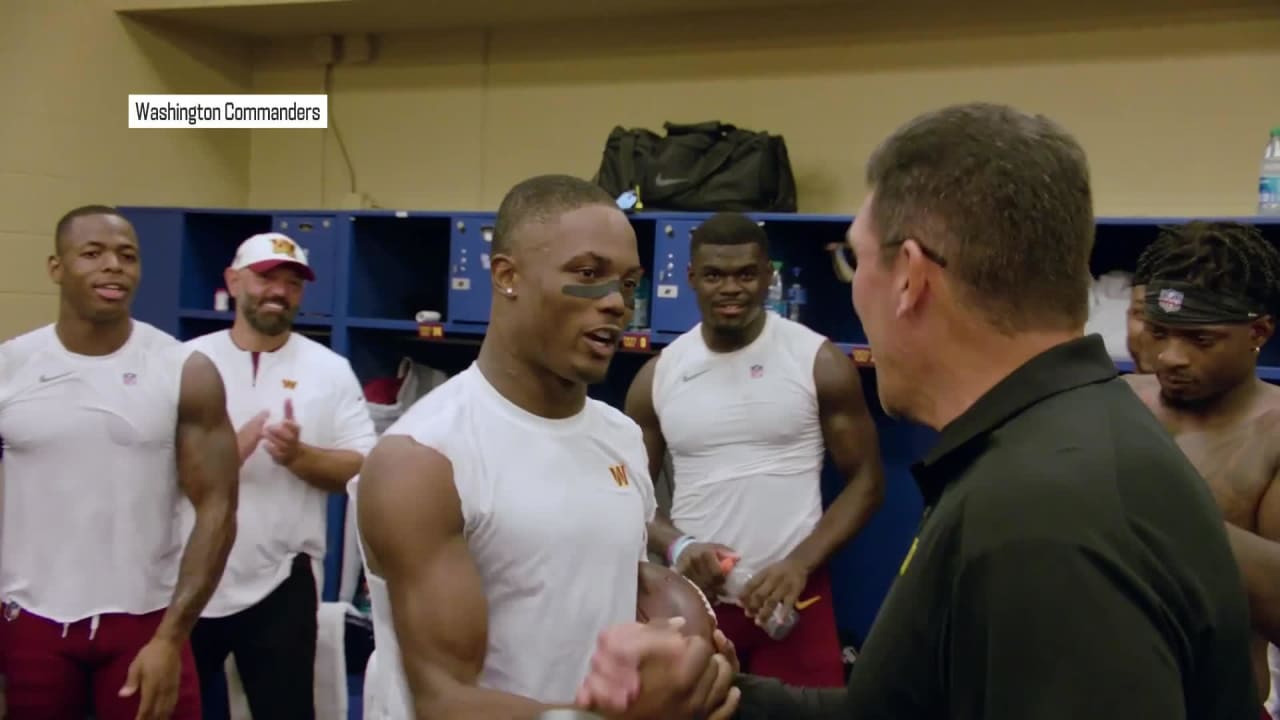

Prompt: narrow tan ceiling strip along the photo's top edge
xmin=111 ymin=0 xmax=856 ymax=37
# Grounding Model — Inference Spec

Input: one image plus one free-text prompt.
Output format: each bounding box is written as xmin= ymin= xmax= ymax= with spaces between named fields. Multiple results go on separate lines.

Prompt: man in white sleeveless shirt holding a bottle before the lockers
xmin=627 ymin=213 xmax=883 ymax=687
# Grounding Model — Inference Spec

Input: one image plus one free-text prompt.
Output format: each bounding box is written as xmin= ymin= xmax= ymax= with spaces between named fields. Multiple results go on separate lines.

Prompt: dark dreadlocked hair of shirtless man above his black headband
xmin=1133 ymin=220 xmax=1280 ymax=314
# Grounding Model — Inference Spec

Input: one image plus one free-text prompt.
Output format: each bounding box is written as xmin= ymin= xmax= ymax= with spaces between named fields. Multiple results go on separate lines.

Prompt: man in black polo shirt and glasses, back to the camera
xmin=576 ymin=104 xmax=1258 ymax=720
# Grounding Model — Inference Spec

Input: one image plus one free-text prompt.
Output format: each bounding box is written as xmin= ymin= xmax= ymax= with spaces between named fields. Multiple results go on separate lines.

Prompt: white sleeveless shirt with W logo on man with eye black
xmin=349 ymin=364 xmax=657 ymax=719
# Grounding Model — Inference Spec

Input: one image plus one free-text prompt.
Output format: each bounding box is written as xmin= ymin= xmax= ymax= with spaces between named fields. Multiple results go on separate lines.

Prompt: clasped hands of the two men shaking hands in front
xmin=570 ymin=618 xmax=741 ymax=720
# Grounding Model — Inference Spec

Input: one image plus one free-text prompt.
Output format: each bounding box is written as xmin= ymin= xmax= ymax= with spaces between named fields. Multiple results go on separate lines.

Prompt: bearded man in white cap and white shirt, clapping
xmin=189 ymin=233 xmax=376 ymax=720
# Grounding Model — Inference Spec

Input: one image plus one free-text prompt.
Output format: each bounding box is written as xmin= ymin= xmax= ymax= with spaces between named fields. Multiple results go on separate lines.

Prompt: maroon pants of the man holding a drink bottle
xmin=716 ymin=569 xmax=845 ymax=688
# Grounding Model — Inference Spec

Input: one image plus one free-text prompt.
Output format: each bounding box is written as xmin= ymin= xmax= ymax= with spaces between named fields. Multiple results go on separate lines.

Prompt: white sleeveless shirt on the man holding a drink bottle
xmin=653 ymin=311 xmax=827 ymax=568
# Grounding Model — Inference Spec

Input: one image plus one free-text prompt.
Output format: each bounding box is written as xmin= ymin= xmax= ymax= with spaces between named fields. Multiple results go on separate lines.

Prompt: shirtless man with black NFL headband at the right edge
xmin=1125 ymin=222 xmax=1280 ymax=694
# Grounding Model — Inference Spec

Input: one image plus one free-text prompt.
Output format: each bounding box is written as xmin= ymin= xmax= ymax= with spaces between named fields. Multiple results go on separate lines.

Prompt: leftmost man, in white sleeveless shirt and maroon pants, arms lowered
xmin=0 ymin=206 xmax=239 ymax=720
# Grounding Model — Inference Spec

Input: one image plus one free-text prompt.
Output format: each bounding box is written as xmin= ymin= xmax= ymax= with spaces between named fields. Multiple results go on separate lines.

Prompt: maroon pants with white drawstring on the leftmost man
xmin=0 ymin=605 xmax=200 ymax=720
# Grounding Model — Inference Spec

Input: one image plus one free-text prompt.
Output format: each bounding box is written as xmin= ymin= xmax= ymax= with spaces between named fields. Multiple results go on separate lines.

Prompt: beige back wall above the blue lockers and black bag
xmin=250 ymin=0 xmax=1280 ymax=214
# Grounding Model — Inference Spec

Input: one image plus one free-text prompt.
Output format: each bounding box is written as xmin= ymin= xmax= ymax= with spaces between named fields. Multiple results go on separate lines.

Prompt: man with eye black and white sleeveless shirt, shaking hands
xmin=353 ymin=176 xmax=736 ymax=720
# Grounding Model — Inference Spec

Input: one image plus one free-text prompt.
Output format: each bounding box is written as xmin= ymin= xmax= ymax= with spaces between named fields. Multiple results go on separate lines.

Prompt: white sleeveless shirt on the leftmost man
xmin=0 ymin=320 xmax=189 ymax=623
